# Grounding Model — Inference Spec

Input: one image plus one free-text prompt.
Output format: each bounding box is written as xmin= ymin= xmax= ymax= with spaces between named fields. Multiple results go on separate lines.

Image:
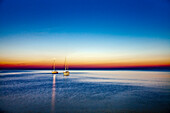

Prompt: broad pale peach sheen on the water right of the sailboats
xmin=69 ymin=71 xmax=170 ymax=87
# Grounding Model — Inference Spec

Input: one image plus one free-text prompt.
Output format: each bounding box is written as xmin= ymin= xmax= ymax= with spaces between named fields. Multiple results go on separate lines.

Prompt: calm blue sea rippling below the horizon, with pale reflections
xmin=0 ymin=70 xmax=170 ymax=113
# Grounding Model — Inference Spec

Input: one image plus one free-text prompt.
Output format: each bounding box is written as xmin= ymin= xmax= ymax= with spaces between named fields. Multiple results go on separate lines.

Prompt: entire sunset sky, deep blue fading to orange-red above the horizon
xmin=0 ymin=0 xmax=170 ymax=69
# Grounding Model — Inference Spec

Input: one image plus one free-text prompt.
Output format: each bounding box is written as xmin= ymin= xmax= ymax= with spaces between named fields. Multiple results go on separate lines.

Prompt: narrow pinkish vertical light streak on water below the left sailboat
xmin=51 ymin=74 xmax=56 ymax=113
